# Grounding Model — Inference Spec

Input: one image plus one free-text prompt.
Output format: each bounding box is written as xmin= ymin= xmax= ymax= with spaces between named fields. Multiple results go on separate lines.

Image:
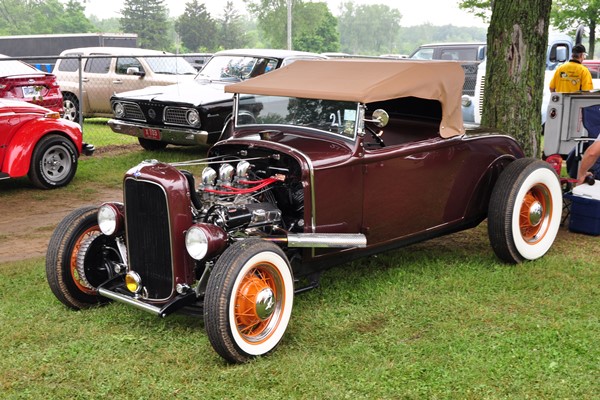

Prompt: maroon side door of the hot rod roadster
xmin=363 ymin=138 xmax=470 ymax=245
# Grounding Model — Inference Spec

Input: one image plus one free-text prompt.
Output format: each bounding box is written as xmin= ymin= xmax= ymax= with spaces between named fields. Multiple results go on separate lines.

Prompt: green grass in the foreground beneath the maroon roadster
xmin=0 ymin=228 xmax=600 ymax=399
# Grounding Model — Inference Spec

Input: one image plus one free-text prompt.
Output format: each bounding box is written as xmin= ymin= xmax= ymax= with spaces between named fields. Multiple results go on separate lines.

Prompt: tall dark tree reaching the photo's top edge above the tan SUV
xmin=120 ymin=0 xmax=170 ymax=50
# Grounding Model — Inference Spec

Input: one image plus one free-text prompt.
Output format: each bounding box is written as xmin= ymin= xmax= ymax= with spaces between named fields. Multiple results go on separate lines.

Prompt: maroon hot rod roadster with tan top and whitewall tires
xmin=46 ymin=60 xmax=562 ymax=363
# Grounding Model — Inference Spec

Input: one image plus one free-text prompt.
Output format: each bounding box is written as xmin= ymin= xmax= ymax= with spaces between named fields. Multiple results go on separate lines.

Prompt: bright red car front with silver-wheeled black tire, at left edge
xmin=0 ymin=99 xmax=94 ymax=189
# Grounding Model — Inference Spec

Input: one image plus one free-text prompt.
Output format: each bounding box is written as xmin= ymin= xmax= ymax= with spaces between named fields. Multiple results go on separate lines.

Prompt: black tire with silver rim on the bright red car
xmin=28 ymin=134 xmax=77 ymax=189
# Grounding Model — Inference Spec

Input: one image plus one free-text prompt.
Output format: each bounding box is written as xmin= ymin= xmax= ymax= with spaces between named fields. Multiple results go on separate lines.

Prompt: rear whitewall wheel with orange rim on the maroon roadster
xmin=488 ymin=158 xmax=562 ymax=264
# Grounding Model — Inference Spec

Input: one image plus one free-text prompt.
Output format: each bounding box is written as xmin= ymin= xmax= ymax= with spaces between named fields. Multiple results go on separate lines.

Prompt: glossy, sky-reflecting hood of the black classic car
xmin=113 ymin=80 xmax=233 ymax=107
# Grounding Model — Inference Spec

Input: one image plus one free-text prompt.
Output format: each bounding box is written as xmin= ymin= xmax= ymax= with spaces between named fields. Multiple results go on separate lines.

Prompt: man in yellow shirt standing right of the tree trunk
xmin=550 ymin=44 xmax=594 ymax=92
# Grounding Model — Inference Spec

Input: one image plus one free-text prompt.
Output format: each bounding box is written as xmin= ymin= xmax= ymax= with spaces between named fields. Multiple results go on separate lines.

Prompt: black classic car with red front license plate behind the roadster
xmin=108 ymin=49 xmax=326 ymax=150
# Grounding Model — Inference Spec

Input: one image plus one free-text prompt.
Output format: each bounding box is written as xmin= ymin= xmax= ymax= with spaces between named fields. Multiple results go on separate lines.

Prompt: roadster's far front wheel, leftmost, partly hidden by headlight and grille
xmin=46 ymin=207 xmax=121 ymax=310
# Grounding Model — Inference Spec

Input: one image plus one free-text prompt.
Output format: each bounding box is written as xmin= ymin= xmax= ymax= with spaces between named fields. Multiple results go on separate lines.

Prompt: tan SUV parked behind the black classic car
xmin=52 ymin=47 xmax=197 ymax=121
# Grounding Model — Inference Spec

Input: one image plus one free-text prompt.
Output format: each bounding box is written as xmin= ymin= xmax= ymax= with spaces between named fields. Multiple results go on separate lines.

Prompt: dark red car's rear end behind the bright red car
xmin=0 ymin=54 xmax=63 ymax=114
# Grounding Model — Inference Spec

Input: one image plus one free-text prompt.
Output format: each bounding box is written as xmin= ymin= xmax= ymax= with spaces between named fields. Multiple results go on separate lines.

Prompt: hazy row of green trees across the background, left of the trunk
xmin=0 ymin=0 xmax=486 ymax=55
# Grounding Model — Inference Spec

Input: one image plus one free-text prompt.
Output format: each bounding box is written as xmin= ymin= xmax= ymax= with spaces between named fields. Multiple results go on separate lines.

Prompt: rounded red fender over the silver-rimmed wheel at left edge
xmin=2 ymin=118 xmax=82 ymax=177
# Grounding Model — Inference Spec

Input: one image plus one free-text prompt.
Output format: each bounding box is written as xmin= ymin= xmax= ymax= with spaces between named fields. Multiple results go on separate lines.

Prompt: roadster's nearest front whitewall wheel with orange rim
xmin=204 ymin=239 xmax=294 ymax=363
